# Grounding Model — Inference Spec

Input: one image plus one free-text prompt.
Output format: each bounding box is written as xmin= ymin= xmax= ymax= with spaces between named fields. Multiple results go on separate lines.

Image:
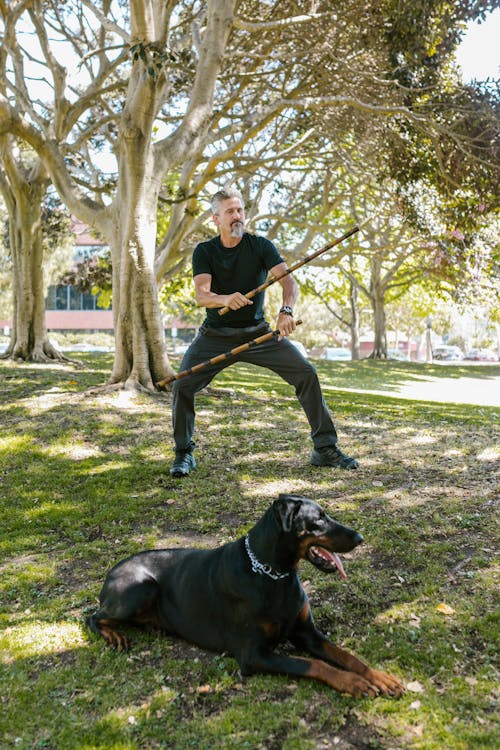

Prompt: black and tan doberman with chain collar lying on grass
xmin=86 ymin=494 xmax=405 ymax=696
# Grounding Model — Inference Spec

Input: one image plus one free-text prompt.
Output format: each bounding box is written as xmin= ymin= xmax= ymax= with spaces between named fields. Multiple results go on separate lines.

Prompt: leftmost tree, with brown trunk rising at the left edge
xmin=0 ymin=3 xmax=126 ymax=362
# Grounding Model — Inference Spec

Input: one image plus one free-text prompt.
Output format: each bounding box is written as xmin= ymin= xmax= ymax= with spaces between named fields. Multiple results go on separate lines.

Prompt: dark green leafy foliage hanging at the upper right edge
xmin=380 ymin=0 xmax=500 ymax=270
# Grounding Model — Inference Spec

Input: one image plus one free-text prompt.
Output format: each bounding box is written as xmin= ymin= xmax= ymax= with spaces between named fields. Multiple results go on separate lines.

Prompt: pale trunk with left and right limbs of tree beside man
xmin=0 ymin=0 xmax=233 ymax=390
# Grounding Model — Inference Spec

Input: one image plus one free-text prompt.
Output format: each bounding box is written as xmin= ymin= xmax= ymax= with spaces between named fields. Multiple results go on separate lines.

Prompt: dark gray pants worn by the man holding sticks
xmin=172 ymin=323 xmax=337 ymax=453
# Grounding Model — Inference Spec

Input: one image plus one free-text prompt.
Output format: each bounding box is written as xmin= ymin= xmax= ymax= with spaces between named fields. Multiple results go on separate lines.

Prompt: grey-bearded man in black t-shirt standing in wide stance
xmin=170 ymin=188 xmax=358 ymax=477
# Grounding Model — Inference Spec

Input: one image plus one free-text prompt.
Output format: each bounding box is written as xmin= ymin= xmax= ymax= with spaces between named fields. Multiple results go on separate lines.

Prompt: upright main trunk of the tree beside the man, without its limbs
xmin=109 ymin=87 xmax=174 ymax=391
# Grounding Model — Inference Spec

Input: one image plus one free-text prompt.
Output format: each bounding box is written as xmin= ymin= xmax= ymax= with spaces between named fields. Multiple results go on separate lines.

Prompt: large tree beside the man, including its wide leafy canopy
xmin=0 ymin=0 xmax=496 ymax=389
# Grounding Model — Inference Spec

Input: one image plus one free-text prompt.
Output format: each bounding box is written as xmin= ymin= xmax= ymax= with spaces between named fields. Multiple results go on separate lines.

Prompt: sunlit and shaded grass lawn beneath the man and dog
xmin=0 ymin=354 xmax=500 ymax=750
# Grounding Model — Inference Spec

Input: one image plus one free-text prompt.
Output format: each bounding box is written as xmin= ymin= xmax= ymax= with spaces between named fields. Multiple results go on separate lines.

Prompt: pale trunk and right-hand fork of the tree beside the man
xmin=103 ymin=0 xmax=235 ymax=390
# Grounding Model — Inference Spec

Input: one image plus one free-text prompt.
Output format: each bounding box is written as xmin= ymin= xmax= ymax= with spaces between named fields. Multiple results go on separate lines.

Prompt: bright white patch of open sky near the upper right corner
xmin=456 ymin=9 xmax=500 ymax=81
